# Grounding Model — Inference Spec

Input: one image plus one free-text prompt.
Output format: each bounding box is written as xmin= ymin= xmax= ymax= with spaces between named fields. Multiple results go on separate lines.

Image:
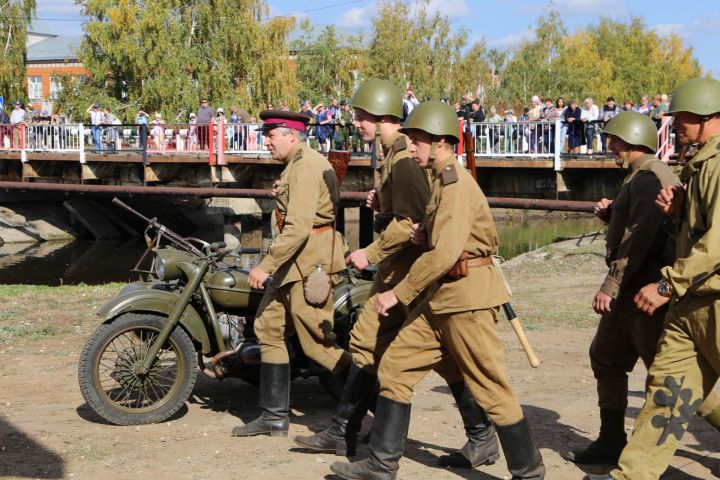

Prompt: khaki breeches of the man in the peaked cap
xmin=255 ymin=282 xmax=350 ymax=374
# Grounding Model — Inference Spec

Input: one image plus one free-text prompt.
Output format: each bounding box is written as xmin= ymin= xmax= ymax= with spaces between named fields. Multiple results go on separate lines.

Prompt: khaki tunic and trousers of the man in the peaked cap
xmin=255 ymin=142 xmax=350 ymax=372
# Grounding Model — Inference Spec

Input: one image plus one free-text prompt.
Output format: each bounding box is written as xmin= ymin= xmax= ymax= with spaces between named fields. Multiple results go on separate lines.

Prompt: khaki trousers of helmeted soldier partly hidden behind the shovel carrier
xmin=350 ymin=279 xmax=462 ymax=384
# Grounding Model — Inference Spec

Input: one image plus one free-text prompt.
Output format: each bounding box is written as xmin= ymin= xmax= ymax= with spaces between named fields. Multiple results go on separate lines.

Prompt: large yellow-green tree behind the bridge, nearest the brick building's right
xmin=59 ymin=0 xmax=295 ymax=120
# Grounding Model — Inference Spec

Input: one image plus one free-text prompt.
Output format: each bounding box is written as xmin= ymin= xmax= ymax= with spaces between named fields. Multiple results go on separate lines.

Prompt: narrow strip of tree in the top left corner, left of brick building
xmin=0 ymin=0 xmax=35 ymax=103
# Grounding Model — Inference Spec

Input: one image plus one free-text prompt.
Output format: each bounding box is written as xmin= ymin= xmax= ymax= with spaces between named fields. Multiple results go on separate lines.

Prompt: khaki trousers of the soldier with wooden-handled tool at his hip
xmin=378 ymin=302 xmax=523 ymax=426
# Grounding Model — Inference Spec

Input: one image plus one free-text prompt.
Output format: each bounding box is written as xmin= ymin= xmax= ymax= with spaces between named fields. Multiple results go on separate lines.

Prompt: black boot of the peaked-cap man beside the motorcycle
xmin=232 ymin=363 xmax=290 ymax=437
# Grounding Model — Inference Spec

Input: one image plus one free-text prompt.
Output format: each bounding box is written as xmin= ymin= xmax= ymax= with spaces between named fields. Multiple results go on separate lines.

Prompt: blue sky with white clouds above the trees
xmin=37 ymin=0 xmax=720 ymax=78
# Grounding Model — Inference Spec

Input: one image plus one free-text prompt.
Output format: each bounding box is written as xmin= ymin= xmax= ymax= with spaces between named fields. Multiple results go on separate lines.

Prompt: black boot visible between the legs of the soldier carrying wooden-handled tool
xmin=438 ymin=382 xmax=500 ymax=468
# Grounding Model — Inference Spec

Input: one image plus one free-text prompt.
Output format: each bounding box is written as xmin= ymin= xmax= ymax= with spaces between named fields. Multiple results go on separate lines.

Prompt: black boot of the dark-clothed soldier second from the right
xmin=569 ymin=408 xmax=627 ymax=465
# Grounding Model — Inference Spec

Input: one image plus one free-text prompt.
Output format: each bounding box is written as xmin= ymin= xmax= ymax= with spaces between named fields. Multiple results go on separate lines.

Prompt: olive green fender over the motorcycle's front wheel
xmin=97 ymin=288 xmax=210 ymax=353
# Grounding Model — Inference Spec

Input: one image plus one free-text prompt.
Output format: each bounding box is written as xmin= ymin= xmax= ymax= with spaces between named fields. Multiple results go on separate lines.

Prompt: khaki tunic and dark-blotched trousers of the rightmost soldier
xmin=611 ymin=136 xmax=720 ymax=480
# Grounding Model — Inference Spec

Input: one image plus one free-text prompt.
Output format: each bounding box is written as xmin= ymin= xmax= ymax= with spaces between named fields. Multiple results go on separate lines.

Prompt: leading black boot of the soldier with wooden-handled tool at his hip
xmin=330 ymin=396 xmax=410 ymax=480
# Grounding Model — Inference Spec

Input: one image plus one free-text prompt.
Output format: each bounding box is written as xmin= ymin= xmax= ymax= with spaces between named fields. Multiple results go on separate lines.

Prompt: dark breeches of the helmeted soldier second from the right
xmin=590 ymin=308 xmax=667 ymax=410
